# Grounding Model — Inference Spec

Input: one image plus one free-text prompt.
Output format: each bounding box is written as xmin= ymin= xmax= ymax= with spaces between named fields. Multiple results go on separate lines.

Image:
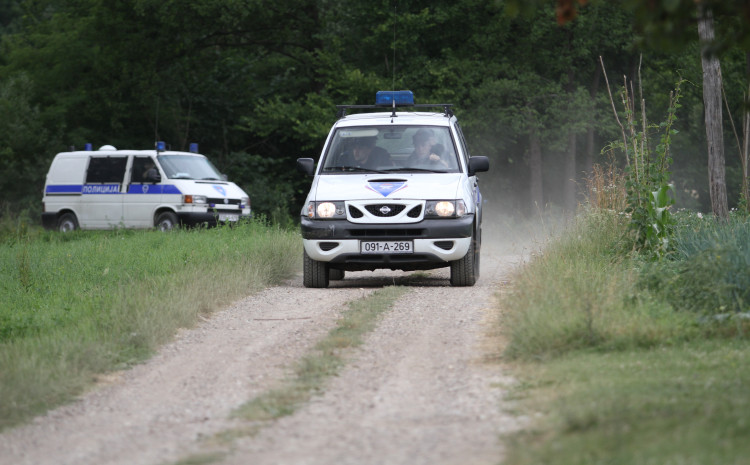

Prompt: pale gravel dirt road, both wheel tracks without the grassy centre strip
xmin=0 ymin=223 xmax=523 ymax=465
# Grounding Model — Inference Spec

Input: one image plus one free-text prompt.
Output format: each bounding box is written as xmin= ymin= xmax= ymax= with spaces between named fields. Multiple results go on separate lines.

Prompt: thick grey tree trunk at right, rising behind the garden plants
xmin=698 ymin=4 xmax=729 ymax=219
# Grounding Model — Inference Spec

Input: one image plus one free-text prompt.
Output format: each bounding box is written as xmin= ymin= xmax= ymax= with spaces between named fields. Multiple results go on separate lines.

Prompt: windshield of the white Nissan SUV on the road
xmin=321 ymin=126 xmax=459 ymax=174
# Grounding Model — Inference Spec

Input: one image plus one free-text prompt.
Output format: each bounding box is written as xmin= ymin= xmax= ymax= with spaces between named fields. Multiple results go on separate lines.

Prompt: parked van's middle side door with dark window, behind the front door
xmin=79 ymin=155 xmax=128 ymax=229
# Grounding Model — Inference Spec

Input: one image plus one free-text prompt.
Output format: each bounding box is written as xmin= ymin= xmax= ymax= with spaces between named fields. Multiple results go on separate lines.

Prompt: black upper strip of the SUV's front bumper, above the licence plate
xmin=301 ymin=215 xmax=474 ymax=240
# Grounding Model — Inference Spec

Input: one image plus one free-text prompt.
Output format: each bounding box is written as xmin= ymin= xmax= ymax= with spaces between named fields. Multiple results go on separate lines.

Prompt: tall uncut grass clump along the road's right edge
xmin=503 ymin=210 xmax=695 ymax=359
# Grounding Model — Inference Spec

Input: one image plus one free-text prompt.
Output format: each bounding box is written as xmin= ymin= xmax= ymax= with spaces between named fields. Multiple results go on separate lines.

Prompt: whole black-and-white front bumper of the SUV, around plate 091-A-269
xmin=301 ymin=215 xmax=474 ymax=271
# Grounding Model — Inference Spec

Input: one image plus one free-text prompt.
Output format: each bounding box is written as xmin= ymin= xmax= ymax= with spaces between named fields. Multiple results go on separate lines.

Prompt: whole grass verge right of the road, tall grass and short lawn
xmin=501 ymin=212 xmax=750 ymax=465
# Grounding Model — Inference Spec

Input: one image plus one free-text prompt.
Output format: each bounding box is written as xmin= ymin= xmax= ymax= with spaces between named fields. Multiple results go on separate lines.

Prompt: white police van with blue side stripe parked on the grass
xmin=42 ymin=142 xmax=250 ymax=231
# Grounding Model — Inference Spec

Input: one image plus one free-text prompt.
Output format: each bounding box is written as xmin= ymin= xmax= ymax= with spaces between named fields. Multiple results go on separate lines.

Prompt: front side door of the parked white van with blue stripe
xmin=123 ymin=155 xmax=162 ymax=228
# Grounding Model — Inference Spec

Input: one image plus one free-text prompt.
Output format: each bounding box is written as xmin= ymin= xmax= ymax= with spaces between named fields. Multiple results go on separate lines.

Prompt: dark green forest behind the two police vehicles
xmin=0 ymin=0 xmax=750 ymax=223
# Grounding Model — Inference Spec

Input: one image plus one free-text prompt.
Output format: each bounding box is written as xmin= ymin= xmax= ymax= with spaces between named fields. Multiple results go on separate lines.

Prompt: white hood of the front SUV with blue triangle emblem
xmin=311 ymin=173 xmax=462 ymax=201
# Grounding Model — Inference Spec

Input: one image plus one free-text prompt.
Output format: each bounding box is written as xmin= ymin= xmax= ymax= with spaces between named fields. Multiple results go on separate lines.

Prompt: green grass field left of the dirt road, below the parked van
xmin=0 ymin=220 xmax=301 ymax=429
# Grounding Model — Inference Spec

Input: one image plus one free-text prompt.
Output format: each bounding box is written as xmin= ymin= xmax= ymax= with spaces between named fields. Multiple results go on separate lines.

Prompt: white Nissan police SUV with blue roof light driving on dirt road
xmin=297 ymin=91 xmax=489 ymax=287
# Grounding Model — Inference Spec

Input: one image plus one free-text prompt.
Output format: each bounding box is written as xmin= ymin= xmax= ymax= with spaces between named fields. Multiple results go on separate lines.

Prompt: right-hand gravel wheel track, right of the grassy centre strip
xmin=221 ymin=245 xmax=520 ymax=465
